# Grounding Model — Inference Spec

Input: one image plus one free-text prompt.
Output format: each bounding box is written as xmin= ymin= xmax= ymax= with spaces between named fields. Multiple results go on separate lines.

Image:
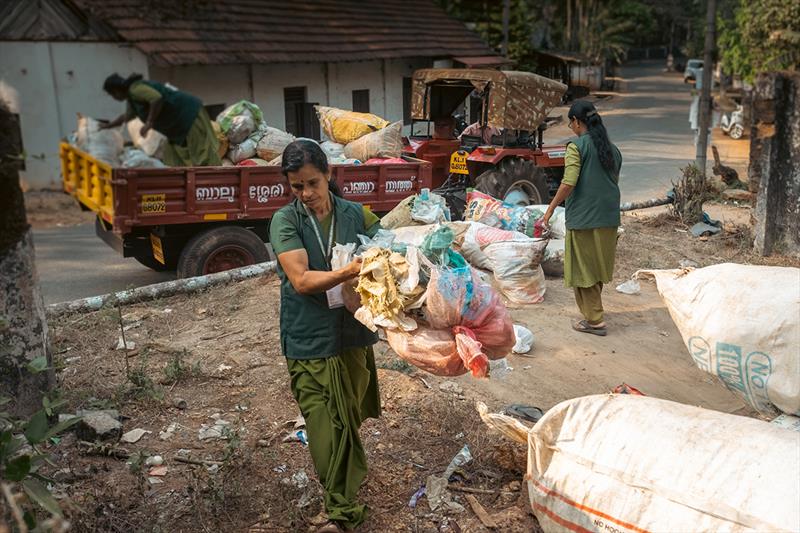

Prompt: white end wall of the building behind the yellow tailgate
xmin=0 ymin=41 xmax=148 ymax=188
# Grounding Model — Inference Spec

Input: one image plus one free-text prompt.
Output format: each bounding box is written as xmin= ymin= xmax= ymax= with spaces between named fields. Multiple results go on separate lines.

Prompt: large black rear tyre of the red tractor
xmin=475 ymin=157 xmax=550 ymax=205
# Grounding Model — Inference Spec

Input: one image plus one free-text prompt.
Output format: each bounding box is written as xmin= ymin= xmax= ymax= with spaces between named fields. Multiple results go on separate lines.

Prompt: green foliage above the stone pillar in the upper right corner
xmin=717 ymin=0 xmax=800 ymax=81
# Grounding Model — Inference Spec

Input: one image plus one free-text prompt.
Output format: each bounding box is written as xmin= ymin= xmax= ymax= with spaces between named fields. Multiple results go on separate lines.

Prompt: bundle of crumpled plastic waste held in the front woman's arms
xmin=334 ymin=224 xmax=516 ymax=377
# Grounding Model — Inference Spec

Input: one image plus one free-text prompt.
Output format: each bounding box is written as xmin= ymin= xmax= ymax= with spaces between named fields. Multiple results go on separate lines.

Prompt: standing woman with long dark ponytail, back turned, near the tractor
xmin=544 ymin=100 xmax=622 ymax=336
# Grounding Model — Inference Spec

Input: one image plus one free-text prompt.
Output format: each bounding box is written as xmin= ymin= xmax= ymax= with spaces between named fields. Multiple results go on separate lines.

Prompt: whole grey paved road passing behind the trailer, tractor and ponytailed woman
xmin=34 ymin=62 xmax=694 ymax=303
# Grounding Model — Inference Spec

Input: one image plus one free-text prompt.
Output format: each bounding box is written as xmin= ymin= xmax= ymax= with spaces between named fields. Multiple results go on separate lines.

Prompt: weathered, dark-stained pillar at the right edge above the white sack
xmin=748 ymin=72 xmax=800 ymax=256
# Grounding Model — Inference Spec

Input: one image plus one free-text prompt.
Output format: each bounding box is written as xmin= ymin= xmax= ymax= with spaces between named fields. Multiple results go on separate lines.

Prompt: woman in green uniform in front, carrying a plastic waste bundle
xmin=270 ymin=139 xmax=381 ymax=532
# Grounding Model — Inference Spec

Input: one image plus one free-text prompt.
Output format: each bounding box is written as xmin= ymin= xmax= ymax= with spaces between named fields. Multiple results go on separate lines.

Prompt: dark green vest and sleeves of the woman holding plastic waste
xmin=269 ymin=196 xmax=380 ymax=359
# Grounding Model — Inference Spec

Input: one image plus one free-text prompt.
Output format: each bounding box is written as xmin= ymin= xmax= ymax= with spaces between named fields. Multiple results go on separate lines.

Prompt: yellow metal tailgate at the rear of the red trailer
xmin=60 ymin=142 xmax=114 ymax=224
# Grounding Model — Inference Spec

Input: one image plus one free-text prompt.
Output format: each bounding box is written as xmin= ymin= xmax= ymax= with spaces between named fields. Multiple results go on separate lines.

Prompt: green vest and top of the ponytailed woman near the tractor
xmin=564 ymin=134 xmax=622 ymax=229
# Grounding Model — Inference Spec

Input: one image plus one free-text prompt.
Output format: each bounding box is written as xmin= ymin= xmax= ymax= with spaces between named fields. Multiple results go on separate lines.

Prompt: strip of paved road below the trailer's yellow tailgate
xmin=33 ymin=224 xmax=175 ymax=303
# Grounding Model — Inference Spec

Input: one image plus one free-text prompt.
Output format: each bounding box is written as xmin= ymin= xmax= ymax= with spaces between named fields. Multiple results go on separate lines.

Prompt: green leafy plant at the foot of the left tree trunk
xmin=0 ymin=361 xmax=80 ymax=531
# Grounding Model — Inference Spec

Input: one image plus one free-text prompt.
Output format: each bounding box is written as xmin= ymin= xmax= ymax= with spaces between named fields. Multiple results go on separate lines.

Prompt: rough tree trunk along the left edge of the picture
xmin=0 ymin=100 xmax=55 ymax=415
